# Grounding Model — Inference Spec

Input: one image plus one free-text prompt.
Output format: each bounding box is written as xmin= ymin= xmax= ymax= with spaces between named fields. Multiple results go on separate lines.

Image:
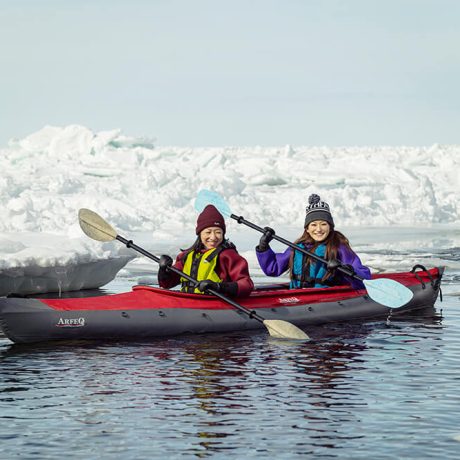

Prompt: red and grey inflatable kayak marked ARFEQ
xmin=0 ymin=266 xmax=444 ymax=343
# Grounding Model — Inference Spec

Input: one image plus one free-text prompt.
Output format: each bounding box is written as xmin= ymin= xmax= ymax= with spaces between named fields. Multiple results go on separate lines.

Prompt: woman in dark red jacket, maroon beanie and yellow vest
xmin=158 ymin=205 xmax=254 ymax=297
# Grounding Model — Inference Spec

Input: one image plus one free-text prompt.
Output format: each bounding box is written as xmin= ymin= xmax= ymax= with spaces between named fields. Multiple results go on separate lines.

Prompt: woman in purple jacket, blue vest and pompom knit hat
xmin=256 ymin=195 xmax=371 ymax=289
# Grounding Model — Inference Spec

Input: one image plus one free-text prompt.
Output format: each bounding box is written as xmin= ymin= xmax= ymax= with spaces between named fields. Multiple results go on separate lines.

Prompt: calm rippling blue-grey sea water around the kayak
xmin=0 ymin=228 xmax=460 ymax=459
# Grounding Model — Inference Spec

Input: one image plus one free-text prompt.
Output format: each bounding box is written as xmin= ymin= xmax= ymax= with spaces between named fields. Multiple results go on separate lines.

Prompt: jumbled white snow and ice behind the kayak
xmin=0 ymin=125 xmax=460 ymax=295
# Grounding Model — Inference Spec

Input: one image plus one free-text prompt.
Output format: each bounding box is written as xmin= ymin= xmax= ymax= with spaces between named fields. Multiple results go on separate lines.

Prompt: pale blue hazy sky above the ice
xmin=0 ymin=0 xmax=460 ymax=147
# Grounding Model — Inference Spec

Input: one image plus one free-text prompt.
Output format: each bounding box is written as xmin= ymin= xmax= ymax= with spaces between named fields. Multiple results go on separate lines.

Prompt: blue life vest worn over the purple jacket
xmin=290 ymin=243 xmax=330 ymax=289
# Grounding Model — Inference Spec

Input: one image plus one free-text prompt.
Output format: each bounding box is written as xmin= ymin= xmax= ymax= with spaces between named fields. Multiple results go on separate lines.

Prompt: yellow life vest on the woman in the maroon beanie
xmin=180 ymin=247 xmax=223 ymax=294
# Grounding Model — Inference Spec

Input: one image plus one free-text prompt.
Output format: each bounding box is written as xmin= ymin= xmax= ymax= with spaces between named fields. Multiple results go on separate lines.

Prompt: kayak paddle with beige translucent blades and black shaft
xmin=78 ymin=208 xmax=309 ymax=340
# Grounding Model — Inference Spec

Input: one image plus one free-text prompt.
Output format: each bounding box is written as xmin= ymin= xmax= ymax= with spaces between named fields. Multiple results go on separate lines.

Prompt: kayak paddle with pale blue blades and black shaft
xmin=195 ymin=190 xmax=414 ymax=308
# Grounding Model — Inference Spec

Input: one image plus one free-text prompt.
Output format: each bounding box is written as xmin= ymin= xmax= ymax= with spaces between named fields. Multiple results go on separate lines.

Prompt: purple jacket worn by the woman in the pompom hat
xmin=256 ymin=245 xmax=371 ymax=289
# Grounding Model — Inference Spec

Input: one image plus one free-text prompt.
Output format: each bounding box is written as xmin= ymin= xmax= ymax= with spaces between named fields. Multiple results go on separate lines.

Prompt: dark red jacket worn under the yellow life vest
xmin=159 ymin=249 xmax=254 ymax=297
